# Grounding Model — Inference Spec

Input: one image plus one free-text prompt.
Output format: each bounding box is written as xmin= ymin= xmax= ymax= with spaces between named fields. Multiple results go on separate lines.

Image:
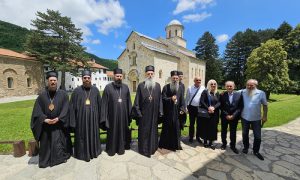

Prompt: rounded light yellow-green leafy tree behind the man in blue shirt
xmin=246 ymin=39 xmax=290 ymax=99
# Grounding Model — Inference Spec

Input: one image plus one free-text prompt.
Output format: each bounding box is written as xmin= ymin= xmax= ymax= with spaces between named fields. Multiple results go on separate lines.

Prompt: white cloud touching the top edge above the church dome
xmin=173 ymin=0 xmax=215 ymax=15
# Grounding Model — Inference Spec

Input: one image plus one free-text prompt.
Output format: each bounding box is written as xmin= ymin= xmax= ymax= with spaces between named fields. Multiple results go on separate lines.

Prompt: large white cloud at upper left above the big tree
xmin=0 ymin=0 xmax=125 ymax=36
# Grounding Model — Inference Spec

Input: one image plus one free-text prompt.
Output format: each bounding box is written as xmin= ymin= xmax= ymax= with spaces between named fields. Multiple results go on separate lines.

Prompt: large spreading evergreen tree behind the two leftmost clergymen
xmin=26 ymin=9 xmax=86 ymax=89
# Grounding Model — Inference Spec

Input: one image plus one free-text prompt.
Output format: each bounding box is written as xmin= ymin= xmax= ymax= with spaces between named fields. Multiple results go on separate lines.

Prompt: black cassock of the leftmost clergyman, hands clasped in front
xmin=30 ymin=89 xmax=71 ymax=168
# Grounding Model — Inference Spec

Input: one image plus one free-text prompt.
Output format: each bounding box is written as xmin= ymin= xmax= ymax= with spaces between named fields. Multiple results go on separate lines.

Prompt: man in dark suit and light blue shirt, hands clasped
xmin=220 ymin=81 xmax=243 ymax=154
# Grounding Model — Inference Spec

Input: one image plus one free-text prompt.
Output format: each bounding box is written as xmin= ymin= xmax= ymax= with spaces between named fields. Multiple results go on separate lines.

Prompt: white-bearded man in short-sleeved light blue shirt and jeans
xmin=241 ymin=79 xmax=268 ymax=160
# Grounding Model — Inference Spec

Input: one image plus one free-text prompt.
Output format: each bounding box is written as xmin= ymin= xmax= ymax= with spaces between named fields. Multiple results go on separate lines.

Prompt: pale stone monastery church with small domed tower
xmin=118 ymin=20 xmax=206 ymax=92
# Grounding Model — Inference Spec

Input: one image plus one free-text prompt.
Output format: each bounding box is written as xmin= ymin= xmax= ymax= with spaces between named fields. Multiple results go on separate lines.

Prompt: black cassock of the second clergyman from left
xmin=70 ymin=86 xmax=101 ymax=161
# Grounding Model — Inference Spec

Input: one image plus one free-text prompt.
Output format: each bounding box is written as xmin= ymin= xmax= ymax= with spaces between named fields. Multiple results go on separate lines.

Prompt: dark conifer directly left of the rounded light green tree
xmin=224 ymin=29 xmax=261 ymax=89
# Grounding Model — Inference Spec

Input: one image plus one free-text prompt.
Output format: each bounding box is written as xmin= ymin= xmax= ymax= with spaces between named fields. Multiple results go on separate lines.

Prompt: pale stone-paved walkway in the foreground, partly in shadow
xmin=0 ymin=118 xmax=300 ymax=180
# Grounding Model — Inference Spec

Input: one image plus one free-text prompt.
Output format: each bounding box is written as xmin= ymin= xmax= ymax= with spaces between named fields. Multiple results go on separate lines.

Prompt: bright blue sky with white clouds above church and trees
xmin=0 ymin=0 xmax=300 ymax=59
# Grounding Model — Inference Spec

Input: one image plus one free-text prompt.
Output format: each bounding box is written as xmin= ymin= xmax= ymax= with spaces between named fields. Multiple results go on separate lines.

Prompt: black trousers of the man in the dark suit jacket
xmin=221 ymin=117 xmax=238 ymax=147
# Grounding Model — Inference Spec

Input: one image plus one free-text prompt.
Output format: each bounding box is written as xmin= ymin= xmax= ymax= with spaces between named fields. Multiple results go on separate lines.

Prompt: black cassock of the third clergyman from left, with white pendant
xmin=101 ymin=82 xmax=132 ymax=156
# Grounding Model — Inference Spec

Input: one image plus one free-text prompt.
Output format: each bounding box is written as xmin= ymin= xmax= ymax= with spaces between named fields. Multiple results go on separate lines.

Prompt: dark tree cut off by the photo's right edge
xmin=285 ymin=24 xmax=300 ymax=94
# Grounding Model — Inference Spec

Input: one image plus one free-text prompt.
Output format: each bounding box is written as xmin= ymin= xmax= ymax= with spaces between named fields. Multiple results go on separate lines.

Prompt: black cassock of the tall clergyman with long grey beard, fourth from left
xmin=132 ymin=82 xmax=163 ymax=157
